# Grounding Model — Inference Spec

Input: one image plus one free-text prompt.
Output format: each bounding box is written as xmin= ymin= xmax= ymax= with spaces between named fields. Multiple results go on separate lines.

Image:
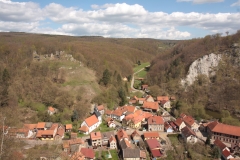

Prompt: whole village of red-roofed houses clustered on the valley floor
xmin=3 ymin=85 xmax=240 ymax=160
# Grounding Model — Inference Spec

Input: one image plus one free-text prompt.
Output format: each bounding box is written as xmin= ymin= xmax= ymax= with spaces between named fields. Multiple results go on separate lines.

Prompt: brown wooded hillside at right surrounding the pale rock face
xmin=147 ymin=31 xmax=240 ymax=125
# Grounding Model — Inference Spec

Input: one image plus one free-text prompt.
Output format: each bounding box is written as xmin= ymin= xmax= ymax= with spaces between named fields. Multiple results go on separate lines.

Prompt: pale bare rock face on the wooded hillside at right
xmin=181 ymin=53 xmax=222 ymax=86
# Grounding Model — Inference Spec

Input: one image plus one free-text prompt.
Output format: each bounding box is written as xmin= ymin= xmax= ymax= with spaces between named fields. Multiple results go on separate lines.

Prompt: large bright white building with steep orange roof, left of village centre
xmin=78 ymin=114 xmax=101 ymax=134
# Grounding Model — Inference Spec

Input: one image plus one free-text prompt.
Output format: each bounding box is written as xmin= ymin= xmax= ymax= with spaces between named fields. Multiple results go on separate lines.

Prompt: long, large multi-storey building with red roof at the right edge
xmin=206 ymin=121 xmax=240 ymax=146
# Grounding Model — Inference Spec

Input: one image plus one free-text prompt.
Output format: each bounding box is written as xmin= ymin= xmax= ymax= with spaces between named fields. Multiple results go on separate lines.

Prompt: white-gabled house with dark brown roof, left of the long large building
xmin=181 ymin=126 xmax=197 ymax=143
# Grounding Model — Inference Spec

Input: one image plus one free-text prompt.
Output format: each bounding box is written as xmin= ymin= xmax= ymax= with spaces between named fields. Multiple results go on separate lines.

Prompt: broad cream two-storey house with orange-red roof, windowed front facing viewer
xmin=148 ymin=116 xmax=164 ymax=131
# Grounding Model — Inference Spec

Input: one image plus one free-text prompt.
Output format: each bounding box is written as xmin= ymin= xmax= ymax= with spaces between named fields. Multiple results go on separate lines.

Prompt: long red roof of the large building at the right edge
xmin=208 ymin=121 xmax=240 ymax=136
